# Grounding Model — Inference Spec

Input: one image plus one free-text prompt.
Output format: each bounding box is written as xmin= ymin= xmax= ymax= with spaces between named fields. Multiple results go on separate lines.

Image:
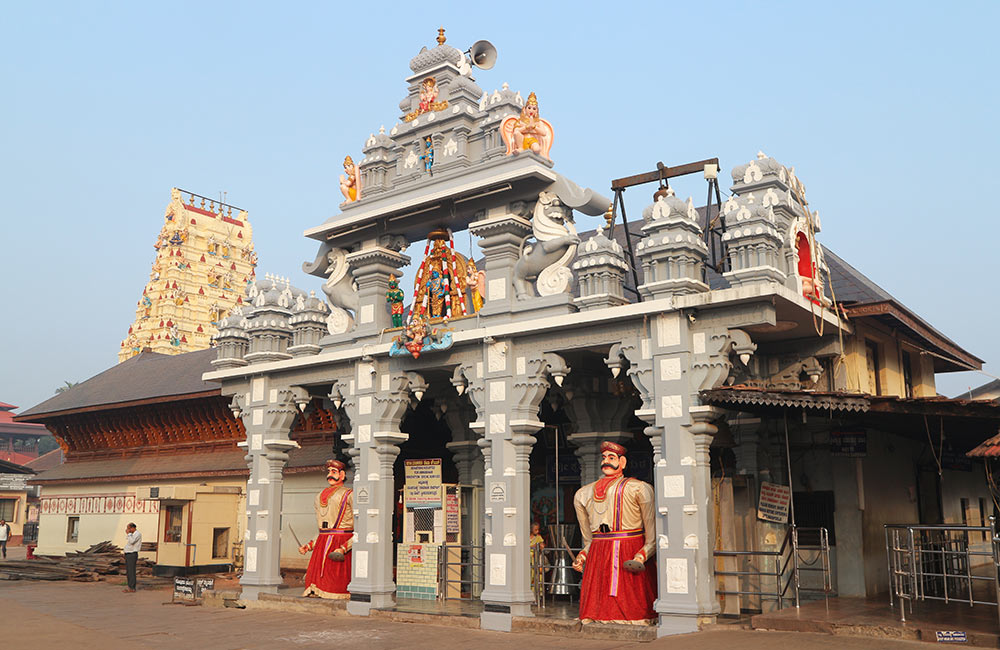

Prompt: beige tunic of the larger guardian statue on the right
xmin=573 ymin=476 xmax=656 ymax=559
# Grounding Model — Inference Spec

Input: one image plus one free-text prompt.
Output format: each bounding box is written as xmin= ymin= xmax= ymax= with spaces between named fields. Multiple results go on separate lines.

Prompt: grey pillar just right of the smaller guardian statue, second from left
xmin=337 ymin=359 xmax=418 ymax=616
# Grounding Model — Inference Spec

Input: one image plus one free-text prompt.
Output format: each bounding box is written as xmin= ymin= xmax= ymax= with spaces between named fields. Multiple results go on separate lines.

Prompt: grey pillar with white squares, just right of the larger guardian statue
xmin=609 ymin=312 xmax=731 ymax=636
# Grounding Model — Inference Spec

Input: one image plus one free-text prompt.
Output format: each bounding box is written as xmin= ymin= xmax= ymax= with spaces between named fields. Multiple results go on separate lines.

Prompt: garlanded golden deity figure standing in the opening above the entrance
xmin=410 ymin=230 xmax=469 ymax=320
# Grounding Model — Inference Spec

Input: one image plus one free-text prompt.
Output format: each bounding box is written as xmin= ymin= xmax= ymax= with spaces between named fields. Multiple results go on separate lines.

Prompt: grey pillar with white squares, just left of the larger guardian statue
xmin=467 ymin=341 xmax=569 ymax=632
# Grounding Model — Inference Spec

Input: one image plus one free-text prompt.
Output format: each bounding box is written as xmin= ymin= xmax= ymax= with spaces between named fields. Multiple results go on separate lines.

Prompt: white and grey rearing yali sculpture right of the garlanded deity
xmin=514 ymin=192 xmax=580 ymax=300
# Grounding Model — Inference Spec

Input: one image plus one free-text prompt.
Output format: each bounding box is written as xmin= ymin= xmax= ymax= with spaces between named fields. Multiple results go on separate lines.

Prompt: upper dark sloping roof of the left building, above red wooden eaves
xmin=17 ymin=348 xmax=219 ymax=419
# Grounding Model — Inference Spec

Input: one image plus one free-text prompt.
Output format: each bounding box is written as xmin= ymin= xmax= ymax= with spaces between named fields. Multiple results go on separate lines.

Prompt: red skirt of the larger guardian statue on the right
xmin=580 ymin=530 xmax=656 ymax=623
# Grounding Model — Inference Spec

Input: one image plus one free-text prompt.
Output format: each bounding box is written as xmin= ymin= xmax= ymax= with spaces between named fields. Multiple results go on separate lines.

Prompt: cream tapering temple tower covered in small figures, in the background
xmin=118 ymin=188 xmax=257 ymax=362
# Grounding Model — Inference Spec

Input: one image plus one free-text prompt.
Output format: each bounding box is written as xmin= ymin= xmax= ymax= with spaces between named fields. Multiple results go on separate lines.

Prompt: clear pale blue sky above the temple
xmin=0 ymin=2 xmax=1000 ymax=408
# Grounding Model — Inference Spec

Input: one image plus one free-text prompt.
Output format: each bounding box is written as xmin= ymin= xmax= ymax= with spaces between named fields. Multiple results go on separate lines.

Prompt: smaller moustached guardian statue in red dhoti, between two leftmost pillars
xmin=299 ymin=460 xmax=354 ymax=598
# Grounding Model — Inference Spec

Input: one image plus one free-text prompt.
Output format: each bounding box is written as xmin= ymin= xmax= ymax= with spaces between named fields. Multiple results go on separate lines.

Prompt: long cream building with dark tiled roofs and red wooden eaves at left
xmin=17 ymin=349 xmax=339 ymax=564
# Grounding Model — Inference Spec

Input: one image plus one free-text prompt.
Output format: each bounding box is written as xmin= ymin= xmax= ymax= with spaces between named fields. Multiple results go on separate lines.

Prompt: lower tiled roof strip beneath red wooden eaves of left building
xmin=33 ymin=444 xmax=332 ymax=483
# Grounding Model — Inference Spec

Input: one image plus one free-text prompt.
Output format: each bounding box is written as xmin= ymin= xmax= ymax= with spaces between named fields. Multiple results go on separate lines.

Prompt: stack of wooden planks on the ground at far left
xmin=0 ymin=542 xmax=153 ymax=582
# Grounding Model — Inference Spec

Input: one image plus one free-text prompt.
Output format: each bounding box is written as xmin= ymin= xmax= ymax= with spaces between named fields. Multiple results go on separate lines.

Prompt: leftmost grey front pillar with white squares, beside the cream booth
xmin=234 ymin=377 xmax=309 ymax=600
